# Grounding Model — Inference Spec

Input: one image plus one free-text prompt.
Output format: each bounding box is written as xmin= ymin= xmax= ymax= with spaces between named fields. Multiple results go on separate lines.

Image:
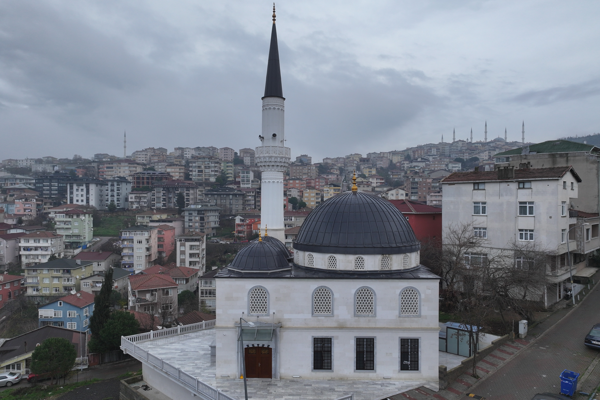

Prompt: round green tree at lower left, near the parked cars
xmin=31 ymin=338 xmax=77 ymax=383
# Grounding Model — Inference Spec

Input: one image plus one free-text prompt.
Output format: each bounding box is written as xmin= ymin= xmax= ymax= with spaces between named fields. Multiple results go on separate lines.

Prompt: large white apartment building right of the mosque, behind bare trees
xmin=442 ymin=167 xmax=600 ymax=305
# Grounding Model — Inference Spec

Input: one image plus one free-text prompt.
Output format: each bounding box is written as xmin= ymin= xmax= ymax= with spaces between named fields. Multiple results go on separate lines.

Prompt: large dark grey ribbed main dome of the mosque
xmin=294 ymin=192 xmax=421 ymax=254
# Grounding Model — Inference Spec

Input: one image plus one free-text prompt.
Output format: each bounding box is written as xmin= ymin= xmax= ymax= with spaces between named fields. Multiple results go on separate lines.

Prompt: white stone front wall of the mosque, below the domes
xmin=216 ymin=278 xmax=439 ymax=383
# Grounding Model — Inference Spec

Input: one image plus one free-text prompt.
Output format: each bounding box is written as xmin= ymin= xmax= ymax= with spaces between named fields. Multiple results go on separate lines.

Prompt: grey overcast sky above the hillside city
xmin=0 ymin=0 xmax=600 ymax=162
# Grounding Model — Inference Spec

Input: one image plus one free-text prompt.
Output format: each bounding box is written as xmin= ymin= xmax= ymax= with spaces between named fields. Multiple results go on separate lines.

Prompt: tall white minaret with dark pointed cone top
xmin=255 ymin=5 xmax=291 ymax=243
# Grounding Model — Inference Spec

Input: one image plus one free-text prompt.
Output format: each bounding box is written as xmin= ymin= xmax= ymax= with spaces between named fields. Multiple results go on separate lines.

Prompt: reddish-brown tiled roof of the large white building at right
xmin=442 ymin=167 xmax=581 ymax=183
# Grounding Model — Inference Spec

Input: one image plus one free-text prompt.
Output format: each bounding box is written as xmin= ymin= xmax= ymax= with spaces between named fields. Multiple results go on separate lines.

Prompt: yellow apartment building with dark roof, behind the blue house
xmin=24 ymin=258 xmax=94 ymax=303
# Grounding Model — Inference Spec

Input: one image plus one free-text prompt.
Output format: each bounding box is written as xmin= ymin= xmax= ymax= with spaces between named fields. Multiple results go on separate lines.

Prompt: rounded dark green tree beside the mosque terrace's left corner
xmin=89 ymin=310 xmax=140 ymax=353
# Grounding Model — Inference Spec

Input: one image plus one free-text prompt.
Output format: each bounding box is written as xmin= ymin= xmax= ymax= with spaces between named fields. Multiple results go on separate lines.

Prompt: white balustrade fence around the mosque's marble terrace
xmin=121 ymin=320 xmax=234 ymax=400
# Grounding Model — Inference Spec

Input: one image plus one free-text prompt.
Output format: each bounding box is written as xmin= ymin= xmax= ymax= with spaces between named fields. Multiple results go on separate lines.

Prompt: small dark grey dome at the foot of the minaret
xmin=229 ymin=239 xmax=290 ymax=272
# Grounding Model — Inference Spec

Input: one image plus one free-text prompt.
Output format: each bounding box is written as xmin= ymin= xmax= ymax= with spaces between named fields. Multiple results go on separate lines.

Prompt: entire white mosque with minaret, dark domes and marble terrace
xmin=122 ymin=7 xmax=440 ymax=399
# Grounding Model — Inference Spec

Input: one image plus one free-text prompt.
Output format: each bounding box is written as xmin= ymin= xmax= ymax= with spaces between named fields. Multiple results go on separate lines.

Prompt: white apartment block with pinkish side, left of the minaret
xmin=121 ymin=225 xmax=158 ymax=273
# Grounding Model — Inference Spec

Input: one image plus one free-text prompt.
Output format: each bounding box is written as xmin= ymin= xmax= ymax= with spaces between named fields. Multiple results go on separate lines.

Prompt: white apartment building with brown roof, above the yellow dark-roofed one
xmin=19 ymin=231 xmax=65 ymax=268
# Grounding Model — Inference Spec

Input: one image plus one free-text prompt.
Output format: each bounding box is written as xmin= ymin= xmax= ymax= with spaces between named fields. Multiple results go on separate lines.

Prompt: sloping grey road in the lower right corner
xmin=462 ymin=285 xmax=600 ymax=400
